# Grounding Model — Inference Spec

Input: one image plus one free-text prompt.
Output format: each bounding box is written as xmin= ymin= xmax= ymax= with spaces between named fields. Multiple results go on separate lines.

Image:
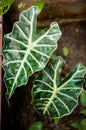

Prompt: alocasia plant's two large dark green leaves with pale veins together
xmin=2 ymin=6 xmax=85 ymax=118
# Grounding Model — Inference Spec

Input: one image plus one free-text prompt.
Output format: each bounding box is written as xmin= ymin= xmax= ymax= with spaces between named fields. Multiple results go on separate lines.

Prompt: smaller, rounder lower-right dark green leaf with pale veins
xmin=32 ymin=57 xmax=85 ymax=118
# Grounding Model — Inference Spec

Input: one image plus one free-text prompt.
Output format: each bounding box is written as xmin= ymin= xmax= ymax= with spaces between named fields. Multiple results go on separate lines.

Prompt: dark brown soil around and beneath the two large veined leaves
xmin=1 ymin=23 xmax=86 ymax=130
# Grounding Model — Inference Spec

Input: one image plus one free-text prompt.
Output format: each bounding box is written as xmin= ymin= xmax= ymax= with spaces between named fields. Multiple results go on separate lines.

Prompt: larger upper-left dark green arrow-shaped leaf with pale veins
xmin=2 ymin=6 xmax=61 ymax=100
